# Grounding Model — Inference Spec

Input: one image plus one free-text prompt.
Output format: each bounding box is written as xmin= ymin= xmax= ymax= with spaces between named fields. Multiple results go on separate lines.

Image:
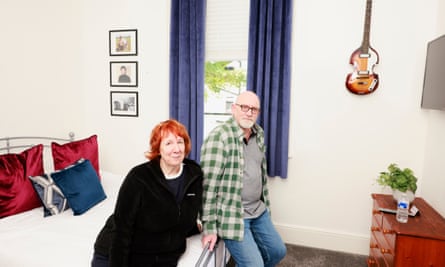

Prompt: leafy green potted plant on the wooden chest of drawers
xmin=377 ymin=163 xmax=417 ymax=202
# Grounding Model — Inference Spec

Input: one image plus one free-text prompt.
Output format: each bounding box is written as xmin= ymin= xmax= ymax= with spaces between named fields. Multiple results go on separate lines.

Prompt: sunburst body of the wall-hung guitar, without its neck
xmin=346 ymin=47 xmax=379 ymax=95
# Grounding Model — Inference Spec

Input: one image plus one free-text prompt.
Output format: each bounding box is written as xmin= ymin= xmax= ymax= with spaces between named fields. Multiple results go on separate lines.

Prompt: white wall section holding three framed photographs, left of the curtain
xmin=77 ymin=0 xmax=170 ymax=174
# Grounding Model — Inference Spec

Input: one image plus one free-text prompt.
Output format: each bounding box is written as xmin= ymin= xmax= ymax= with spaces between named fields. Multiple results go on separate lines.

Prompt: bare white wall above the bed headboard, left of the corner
xmin=0 ymin=0 xmax=85 ymax=137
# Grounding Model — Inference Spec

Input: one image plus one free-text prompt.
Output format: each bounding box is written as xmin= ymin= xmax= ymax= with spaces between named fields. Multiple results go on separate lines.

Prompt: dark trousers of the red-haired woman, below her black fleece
xmin=91 ymin=253 xmax=180 ymax=267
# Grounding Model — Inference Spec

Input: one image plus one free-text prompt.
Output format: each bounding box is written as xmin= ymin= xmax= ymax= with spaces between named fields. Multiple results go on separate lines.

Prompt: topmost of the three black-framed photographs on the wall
xmin=109 ymin=29 xmax=138 ymax=56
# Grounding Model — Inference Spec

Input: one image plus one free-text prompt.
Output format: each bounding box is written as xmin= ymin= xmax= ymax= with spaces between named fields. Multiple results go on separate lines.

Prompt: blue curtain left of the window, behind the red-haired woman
xmin=170 ymin=0 xmax=206 ymax=162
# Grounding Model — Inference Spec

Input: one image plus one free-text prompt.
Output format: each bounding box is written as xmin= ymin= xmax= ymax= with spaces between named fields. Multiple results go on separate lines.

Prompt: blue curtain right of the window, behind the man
xmin=247 ymin=0 xmax=293 ymax=178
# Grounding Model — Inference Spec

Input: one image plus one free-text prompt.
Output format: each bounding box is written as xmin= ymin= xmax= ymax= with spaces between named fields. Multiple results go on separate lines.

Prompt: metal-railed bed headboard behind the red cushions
xmin=0 ymin=132 xmax=74 ymax=154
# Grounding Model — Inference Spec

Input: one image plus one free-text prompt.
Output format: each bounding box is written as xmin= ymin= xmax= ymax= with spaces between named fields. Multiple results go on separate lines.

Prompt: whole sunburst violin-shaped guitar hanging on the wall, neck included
xmin=346 ymin=0 xmax=379 ymax=95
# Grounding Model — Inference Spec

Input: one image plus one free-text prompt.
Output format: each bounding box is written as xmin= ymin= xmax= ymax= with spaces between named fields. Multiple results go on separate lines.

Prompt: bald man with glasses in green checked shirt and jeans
xmin=201 ymin=91 xmax=286 ymax=267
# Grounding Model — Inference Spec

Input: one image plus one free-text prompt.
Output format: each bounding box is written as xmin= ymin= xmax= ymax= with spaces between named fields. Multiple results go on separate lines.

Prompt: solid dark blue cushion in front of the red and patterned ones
xmin=51 ymin=159 xmax=107 ymax=215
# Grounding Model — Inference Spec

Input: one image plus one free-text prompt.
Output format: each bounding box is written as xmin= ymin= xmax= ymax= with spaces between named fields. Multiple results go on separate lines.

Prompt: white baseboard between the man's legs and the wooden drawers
xmin=275 ymin=223 xmax=369 ymax=255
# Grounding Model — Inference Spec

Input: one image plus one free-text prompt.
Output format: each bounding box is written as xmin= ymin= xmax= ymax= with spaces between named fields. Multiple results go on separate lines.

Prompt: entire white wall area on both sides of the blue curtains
xmin=0 ymin=0 xmax=445 ymax=254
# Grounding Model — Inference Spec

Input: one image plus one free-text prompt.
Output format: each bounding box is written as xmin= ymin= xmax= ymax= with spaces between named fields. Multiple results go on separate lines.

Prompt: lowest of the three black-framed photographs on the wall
xmin=110 ymin=91 xmax=139 ymax=117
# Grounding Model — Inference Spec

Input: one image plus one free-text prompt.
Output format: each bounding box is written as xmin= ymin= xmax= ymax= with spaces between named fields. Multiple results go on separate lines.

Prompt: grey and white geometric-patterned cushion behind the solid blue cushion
xmin=29 ymin=174 xmax=69 ymax=217
